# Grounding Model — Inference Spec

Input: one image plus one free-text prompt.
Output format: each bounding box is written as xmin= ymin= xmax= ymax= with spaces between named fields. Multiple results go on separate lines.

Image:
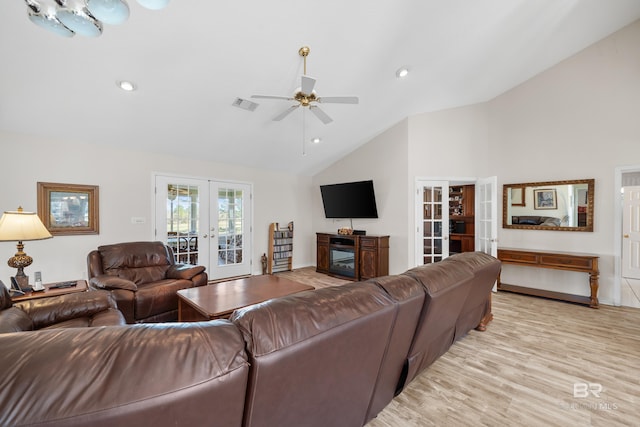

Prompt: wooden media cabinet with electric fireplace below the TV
xmin=316 ymin=233 xmax=389 ymax=280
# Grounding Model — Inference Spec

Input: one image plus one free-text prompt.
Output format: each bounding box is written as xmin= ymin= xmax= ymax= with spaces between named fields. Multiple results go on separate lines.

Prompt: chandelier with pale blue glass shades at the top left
xmin=25 ymin=0 xmax=169 ymax=37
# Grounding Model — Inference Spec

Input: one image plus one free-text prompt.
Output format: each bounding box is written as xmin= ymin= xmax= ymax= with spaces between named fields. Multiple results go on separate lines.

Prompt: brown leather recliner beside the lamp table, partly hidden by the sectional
xmin=0 ymin=282 xmax=125 ymax=334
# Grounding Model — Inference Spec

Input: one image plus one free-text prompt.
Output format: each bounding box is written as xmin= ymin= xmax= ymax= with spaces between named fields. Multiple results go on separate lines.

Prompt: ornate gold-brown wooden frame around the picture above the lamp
xmin=38 ymin=182 xmax=99 ymax=236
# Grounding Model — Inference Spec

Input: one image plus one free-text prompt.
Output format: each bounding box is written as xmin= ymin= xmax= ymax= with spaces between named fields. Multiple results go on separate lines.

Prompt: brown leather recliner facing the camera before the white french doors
xmin=87 ymin=242 xmax=207 ymax=323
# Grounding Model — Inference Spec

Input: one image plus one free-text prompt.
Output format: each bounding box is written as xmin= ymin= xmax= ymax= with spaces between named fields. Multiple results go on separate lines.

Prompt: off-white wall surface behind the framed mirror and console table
xmin=488 ymin=16 xmax=640 ymax=304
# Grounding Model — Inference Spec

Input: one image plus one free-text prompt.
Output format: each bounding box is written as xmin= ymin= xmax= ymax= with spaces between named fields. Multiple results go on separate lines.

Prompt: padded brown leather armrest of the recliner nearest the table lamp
xmin=15 ymin=291 xmax=116 ymax=329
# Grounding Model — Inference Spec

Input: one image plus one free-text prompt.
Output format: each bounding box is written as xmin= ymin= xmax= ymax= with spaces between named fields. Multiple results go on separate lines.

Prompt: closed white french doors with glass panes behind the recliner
xmin=155 ymin=175 xmax=252 ymax=279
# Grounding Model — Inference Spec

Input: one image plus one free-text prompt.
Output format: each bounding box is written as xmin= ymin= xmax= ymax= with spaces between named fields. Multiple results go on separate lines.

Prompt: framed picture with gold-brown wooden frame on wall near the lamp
xmin=38 ymin=182 xmax=99 ymax=236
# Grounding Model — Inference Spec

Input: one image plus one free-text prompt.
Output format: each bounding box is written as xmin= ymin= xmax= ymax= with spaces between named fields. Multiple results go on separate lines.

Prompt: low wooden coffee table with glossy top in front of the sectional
xmin=178 ymin=275 xmax=315 ymax=322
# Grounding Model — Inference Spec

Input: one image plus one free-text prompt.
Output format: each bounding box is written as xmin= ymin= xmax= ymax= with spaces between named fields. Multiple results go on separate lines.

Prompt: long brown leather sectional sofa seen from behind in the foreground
xmin=0 ymin=253 xmax=500 ymax=427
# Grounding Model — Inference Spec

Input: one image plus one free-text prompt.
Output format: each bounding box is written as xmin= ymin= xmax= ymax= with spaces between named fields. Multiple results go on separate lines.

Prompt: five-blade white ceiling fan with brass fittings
xmin=251 ymin=46 xmax=358 ymax=124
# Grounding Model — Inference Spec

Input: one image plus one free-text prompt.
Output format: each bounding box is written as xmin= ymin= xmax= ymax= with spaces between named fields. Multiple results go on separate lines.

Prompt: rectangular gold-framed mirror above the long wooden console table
xmin=502 ymin=179 xmax=595 ymax=231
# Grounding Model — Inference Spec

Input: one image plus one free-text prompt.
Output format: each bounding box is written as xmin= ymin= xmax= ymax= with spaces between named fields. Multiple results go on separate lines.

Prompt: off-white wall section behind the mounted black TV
xmin=312 ymin=120 xmax=410 ymax=274
